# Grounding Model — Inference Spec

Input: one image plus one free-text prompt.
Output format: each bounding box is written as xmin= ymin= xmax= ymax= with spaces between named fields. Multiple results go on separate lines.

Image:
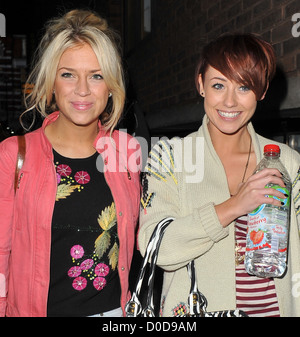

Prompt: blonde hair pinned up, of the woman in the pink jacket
xmin=24 ymin=9 xmax=125 ymax=131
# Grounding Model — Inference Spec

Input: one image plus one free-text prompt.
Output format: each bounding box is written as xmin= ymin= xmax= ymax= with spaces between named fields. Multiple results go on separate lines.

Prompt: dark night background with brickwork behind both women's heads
xmin=0 ymin=0 xmax=300 ymax=149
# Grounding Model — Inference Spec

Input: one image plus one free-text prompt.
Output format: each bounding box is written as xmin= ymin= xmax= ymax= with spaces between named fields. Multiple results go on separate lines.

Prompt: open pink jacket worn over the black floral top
xmin=0 ymin=112 xmax=141 ymax=317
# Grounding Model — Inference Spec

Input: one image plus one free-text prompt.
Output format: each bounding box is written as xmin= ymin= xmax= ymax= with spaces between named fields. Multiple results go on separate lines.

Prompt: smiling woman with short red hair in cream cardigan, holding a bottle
xmin=139 ymin=34 xmax=300 ymax=316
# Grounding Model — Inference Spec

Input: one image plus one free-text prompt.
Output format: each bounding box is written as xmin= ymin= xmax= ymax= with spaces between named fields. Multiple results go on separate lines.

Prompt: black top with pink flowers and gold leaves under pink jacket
xmin=47 ymin=151 xmax=121 ymax=317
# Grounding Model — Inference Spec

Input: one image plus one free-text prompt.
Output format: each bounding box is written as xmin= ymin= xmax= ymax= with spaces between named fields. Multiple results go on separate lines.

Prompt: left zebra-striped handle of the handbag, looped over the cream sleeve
xmin=125 ymin=217 xmax=174 ymax=317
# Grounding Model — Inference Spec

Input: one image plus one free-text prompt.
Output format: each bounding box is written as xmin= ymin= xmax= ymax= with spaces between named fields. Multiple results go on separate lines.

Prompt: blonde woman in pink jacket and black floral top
xmin=0 ymin=10 xmax=140 ymax=317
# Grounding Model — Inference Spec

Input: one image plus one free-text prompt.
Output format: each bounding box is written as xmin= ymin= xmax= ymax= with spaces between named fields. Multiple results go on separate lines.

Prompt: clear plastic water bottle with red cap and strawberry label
xmin=245 ymin=144 xmax=292 ymax=278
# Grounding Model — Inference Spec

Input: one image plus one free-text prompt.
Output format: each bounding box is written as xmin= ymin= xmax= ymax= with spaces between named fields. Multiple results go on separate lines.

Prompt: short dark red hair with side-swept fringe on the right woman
xmin=195 ymin=34 xmax=276 ymax=100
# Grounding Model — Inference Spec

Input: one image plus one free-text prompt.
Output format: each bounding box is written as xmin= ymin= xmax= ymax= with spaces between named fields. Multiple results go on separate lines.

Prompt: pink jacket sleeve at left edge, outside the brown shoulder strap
xmin=0 ymin=137 xmax=17 ymax=317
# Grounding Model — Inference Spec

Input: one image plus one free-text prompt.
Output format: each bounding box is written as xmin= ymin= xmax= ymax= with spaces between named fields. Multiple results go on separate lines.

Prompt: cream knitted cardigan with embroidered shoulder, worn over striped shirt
xmin=138 ymin=116 xmax=300 ymax=316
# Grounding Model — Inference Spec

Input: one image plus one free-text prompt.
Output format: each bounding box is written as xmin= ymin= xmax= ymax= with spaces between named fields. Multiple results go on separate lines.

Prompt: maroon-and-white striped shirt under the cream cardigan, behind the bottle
xmin=235 ymin=216 xmax=280 ymax=317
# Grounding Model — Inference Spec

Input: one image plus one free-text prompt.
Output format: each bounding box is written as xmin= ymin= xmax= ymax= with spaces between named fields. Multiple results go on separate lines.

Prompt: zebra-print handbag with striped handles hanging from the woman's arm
xmin=125 ymin=217 xmax=247 ymax=317
